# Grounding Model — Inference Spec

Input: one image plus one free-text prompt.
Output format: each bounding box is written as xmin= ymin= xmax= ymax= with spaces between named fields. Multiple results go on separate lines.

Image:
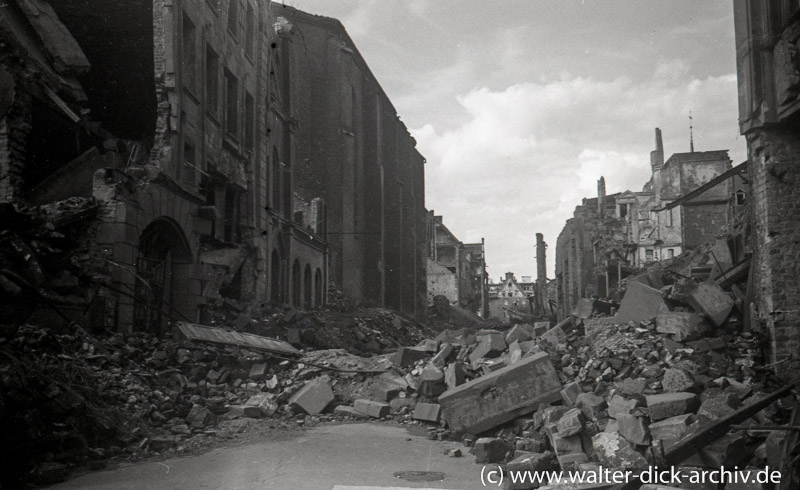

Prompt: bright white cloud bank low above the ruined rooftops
xmin=412 ymin=66 xmax=745 ymax=277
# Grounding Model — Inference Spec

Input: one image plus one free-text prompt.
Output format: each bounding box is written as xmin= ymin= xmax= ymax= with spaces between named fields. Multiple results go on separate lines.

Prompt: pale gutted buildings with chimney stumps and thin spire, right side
xmin=556 ymin=129 xmax=747 ymax=318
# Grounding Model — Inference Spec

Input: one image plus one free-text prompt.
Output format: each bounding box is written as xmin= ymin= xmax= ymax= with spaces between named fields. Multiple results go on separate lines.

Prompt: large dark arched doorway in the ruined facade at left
xmin=133 ymin=218 xmax=192 ymax=335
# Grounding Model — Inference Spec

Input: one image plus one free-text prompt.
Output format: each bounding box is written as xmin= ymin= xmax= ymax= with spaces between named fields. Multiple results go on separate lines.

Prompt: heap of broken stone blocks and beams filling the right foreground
xmin=336 ymin=266 xmax=793 ymax=488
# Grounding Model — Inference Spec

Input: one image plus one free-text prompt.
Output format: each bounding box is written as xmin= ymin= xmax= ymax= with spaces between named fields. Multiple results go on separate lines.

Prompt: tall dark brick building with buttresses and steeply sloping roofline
xmin=272 ymin=3 xmax=426 ymax=313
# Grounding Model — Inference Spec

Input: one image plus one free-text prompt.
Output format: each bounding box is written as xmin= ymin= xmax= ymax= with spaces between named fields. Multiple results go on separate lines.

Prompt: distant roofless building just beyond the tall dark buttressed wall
xmin=426 ymin=211 xmax=488 ymax=318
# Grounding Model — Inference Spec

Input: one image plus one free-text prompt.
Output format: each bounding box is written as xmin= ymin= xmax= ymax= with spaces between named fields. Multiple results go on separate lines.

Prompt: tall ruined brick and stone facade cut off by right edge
xmin=733 ymin=0 xmax=800 ymax=373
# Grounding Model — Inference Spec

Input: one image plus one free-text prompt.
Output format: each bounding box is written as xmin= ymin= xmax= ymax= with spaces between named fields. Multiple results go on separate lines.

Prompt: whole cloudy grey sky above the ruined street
xmin=285 ymin=0 xmax=746 ymax=280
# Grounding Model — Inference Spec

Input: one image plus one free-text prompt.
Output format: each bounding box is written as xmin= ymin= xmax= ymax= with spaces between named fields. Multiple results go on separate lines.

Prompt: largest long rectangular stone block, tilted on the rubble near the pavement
xmin=439 ymin=352 xmax=561 ymax=434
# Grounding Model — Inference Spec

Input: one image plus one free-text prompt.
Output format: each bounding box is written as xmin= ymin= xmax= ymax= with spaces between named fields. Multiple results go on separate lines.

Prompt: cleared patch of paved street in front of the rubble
xmin=52 ymin=424 xmax=482 ymax=490
